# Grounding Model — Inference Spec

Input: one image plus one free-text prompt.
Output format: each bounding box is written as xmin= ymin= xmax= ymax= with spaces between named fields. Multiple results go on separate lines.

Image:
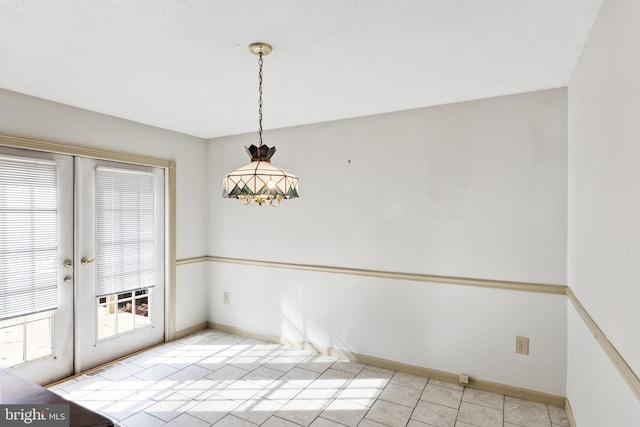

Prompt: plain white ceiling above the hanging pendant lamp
xmin=0 ymin=0 xmax=603 ymax=138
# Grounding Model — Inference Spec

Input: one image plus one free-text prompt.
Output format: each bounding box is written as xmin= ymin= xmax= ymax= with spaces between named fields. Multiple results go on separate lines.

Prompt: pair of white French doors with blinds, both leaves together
xmin=0 ymin=147 xmax=165 ymax=384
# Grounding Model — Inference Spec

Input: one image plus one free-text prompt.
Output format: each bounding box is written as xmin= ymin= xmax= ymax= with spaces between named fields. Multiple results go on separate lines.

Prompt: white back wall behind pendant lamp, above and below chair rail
xmin=209 ymin=89 xmax=567 ymax=395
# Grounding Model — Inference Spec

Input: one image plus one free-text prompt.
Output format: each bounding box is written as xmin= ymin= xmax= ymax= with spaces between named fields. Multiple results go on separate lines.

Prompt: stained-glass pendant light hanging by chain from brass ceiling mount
xmin=222 ymin=43 xmax=298 ymax=206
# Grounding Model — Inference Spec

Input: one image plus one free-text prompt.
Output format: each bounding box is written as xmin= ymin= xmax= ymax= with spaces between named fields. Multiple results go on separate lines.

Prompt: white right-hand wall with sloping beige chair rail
xmin=568 ymin=0 xmax=640 ymax=427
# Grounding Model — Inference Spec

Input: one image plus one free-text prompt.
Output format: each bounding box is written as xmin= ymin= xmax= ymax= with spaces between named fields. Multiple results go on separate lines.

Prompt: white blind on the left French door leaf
xmin=0 ymin=156 xmax=58 ymax=319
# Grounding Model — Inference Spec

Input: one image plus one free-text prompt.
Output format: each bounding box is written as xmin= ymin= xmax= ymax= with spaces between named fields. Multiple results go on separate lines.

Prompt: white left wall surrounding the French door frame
xmin=0 ymin=89 xmax=208 ymax=330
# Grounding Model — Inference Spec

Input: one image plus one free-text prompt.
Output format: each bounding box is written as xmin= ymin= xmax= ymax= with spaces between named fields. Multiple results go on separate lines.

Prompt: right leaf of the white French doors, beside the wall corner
xmin=75 ymin=158 xmax=165 ymax=372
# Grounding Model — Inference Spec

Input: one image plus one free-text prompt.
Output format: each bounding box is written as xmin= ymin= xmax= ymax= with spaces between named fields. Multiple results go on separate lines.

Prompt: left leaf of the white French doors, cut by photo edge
xmin=0 ymin=147 xmax=73 ymax=384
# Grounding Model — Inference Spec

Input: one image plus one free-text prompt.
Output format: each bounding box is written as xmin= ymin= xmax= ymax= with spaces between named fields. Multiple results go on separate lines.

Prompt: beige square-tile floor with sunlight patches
xmin=51 ymin=330 xmax=569 ymax=427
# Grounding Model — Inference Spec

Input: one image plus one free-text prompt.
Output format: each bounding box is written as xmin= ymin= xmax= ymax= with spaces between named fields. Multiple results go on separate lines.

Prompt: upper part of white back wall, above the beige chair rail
xmin=209 ymin=89 xmax=567 ymax=284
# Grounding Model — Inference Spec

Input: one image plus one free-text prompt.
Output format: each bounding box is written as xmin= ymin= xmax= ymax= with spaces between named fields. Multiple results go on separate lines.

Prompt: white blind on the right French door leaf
xmin=96 ymin=167 xmax=156 ymax=296
